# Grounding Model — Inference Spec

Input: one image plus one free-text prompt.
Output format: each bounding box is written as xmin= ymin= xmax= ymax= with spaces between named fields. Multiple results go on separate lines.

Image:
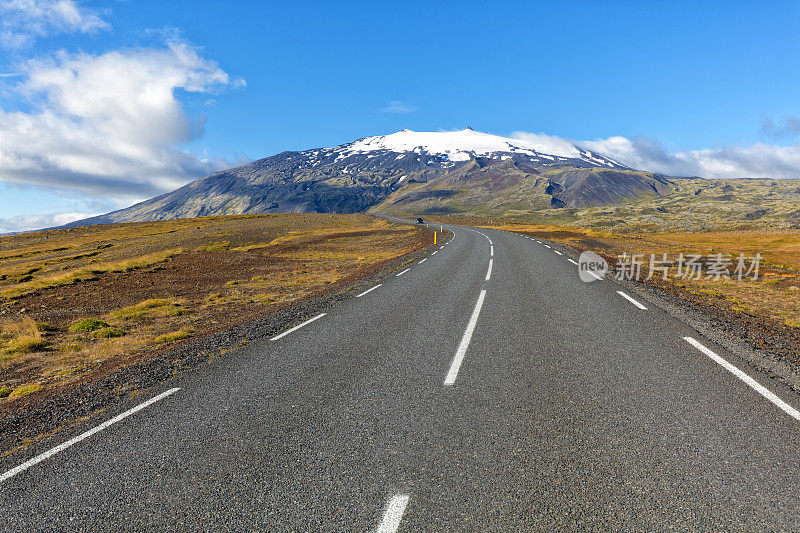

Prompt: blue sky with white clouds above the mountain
xmin=0 ymin=0 xmax=800 ymax=231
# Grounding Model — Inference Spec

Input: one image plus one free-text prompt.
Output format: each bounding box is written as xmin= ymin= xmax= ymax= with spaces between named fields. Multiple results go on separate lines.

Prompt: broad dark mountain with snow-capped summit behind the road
xmin=71 ymin=128 xmax=673 ymax=225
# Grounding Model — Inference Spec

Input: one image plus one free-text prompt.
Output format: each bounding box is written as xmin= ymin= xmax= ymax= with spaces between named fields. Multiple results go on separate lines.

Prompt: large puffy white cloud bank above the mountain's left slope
xmin=0 ymin=41 xmax=241 ymax=202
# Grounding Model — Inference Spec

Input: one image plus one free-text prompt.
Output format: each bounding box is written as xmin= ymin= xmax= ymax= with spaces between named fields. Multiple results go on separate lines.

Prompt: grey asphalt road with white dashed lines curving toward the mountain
xmin=0 ymin=222 xmax=800 ymax=531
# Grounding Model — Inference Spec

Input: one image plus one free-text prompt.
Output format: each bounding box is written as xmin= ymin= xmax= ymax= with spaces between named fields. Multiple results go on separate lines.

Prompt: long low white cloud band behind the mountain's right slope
xmin=512 ymin=132 xmax=800 ymax=179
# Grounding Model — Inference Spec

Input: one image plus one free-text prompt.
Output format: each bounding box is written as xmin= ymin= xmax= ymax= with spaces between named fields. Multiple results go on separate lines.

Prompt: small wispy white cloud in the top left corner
xmin=0 ymin=0 xmax=109 ymax=49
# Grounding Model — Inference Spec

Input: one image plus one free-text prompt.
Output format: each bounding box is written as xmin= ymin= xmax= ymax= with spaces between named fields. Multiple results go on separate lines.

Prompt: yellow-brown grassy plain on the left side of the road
xmin=0 ymin=214 xmax=430 ymax=408
